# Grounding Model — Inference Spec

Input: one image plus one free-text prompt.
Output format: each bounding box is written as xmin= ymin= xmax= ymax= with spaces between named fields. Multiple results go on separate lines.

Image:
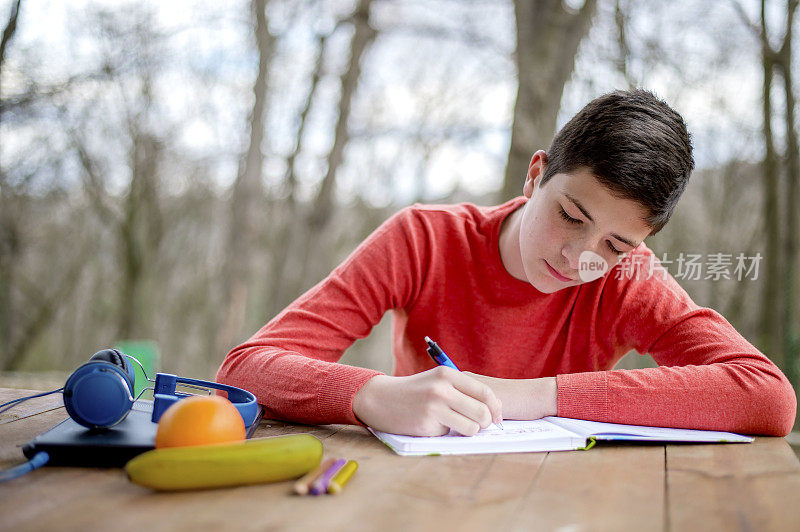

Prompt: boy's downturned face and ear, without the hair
xmin=519 ymin=151 xmax=651 ymax=293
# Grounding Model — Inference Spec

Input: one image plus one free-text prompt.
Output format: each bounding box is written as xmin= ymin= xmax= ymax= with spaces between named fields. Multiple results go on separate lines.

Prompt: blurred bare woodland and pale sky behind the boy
xmin=0 ymin=0 xmax=800 ymax=428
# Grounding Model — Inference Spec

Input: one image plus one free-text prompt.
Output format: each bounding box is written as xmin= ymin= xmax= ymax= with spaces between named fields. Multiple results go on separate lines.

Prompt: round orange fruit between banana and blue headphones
xmin=156 ymin=395 xmax=245 ymax=449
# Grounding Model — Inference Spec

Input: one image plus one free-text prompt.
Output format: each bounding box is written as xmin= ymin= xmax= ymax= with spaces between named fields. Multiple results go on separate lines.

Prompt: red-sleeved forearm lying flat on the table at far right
xmin=558 ymin=362 xmax=797 ymax=436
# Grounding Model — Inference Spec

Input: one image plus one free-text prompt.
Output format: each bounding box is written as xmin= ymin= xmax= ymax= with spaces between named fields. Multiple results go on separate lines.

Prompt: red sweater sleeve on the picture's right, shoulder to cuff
xmin=557 ymin=250 xmax=797 ymax=436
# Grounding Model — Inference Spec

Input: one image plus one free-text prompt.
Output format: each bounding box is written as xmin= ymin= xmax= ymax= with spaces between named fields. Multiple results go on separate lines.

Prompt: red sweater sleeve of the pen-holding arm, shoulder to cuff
xmin=216 ymin=208 xmax=428 ymax=424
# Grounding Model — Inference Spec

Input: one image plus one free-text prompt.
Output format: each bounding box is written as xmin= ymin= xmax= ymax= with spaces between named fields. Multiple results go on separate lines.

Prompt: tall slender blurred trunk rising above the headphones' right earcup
xmin=215 ymin=0 xmax=275 ymax=353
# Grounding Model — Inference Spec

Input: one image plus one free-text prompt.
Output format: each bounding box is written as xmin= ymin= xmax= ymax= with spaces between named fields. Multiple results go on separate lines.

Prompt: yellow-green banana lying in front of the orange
xmin=125 ymin=434 xmax=322 ymax=491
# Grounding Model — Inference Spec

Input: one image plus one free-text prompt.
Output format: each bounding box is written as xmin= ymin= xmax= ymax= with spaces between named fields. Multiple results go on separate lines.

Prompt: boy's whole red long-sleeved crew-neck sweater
xmin=217 ymin=198 xmax=797 ymax=436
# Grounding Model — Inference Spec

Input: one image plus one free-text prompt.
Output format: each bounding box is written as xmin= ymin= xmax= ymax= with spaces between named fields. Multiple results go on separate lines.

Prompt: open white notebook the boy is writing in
xmin=369 ymin=416 xmax=753 ymax=456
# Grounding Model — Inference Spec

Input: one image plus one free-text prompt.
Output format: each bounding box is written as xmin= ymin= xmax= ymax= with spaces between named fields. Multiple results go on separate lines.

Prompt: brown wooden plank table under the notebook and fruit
xmin=0 ymin=389 xmax=800 ymax=531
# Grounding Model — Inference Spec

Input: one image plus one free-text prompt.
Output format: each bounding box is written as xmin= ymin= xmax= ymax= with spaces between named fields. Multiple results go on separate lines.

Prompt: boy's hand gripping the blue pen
xmin=353 ymin=366 xmax=503 ymax=436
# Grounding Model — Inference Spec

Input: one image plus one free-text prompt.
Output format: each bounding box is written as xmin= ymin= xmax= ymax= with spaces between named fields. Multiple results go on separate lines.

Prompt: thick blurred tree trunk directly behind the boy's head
xmin=500 ymin=0 xmax=597 ymax=201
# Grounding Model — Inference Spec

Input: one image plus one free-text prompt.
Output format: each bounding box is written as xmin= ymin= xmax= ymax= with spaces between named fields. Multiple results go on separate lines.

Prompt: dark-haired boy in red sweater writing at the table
xmin=217 ymin=90 xmax=797 ymax=436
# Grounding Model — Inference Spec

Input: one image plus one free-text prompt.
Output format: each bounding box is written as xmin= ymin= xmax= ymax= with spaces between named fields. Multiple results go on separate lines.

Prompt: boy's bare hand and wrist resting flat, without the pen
xmin=462 ymin=371 xmax=558 ymax=419
